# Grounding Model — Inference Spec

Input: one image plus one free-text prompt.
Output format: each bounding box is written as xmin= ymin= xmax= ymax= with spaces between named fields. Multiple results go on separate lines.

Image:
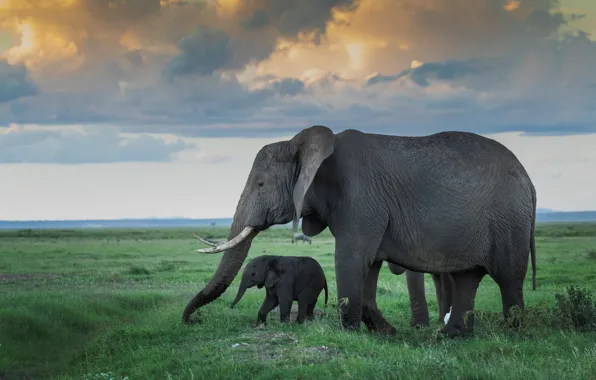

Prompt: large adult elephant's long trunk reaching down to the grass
xmin=182 ymin=209 xmax=258 ymax=323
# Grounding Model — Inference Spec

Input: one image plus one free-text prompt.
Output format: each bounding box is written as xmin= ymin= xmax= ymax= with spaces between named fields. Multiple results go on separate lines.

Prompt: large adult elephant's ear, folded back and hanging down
xmin=292 ymin=125 xmax=335 ymax=233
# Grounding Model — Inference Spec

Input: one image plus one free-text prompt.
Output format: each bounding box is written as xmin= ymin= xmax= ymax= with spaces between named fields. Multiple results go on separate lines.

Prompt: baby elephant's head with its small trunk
xmin=231 ymin=255 xmax=284 ymax=308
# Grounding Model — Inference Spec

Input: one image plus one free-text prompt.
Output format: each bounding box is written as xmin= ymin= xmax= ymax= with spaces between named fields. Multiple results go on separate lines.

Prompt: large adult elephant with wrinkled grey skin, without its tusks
xmin=182 ymin=126 xmax=536 ymax=336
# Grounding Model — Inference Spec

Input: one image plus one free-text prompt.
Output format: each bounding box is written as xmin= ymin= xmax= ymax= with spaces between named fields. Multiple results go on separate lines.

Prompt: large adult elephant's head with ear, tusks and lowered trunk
xmin=182 ymin=126 xmax=335 ymax=322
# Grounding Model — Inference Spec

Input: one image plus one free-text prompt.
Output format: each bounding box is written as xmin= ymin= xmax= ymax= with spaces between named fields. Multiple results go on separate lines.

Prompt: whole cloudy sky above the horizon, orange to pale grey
xmin=0 ymin=0 xmax=596 ymax=220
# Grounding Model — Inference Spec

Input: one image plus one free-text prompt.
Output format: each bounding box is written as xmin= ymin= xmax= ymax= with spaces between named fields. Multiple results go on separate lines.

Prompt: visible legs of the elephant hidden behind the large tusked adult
xmin=388 ymin=263 xmax=455 ymax=327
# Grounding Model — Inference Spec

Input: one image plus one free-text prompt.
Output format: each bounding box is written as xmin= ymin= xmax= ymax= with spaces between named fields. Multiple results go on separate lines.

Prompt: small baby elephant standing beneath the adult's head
xmin=232 ymin=255 xmax=328 ymax=324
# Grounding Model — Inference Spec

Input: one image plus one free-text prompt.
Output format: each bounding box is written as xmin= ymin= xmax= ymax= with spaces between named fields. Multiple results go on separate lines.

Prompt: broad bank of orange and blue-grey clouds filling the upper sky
xmin=0 ymin=0 xmax=596 ymax=140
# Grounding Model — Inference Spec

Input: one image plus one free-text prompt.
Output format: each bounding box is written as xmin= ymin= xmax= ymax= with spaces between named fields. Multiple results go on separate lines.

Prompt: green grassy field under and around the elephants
xmin=0 ymin=224 xmax=596 ymax=380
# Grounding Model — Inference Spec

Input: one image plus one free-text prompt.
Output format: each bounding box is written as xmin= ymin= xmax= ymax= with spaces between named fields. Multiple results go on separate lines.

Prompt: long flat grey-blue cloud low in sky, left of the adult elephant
xmin=0 ymin=127 xmax=196 ymax=164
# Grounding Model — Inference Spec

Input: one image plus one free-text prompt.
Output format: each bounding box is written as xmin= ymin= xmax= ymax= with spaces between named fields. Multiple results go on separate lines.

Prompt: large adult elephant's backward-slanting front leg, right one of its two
xmin=362 ymin=261 xmax=397 ymax=335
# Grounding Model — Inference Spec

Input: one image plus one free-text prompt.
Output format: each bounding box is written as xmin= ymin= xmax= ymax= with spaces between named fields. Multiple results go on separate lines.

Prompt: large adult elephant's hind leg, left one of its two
xmin=440 ymin=268 xmax=486 ymax=337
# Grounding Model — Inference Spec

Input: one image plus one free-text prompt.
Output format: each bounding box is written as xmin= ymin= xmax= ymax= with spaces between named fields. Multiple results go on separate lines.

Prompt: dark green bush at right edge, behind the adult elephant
xmin=555 ymin=285 xmax=596 ymax=331
